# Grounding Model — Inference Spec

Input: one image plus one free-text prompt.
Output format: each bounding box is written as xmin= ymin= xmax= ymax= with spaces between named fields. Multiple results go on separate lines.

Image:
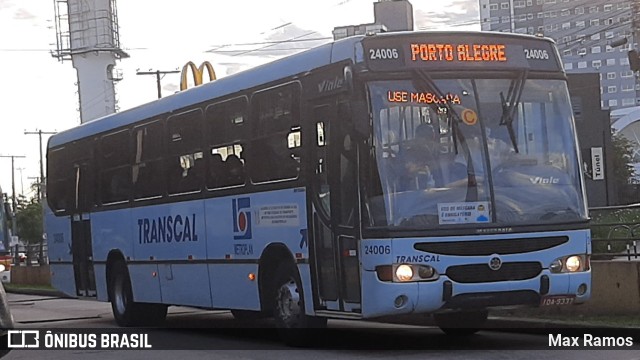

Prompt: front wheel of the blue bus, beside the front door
xmin=272 ymin=263 xmax=327 ymax=346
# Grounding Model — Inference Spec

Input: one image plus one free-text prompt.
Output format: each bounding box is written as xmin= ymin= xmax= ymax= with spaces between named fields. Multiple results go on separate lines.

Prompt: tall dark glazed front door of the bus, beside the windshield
xmin=311 ymin=100 xmax=361 ymax=313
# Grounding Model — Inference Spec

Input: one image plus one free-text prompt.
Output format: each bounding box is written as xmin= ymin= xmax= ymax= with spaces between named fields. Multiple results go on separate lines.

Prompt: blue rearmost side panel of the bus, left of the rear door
xmin=45 ymin=205 xmax=76 ymax=297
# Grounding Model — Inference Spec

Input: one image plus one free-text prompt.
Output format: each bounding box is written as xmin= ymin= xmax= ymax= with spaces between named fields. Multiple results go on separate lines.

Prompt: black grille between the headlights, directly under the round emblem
xmin=446 ymin=262 xmax=542 ymax=283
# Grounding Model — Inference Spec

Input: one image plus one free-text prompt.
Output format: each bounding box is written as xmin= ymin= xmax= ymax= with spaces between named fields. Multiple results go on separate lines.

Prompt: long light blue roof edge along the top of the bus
xmin=48 ymin=31 xmax=551 ymax=148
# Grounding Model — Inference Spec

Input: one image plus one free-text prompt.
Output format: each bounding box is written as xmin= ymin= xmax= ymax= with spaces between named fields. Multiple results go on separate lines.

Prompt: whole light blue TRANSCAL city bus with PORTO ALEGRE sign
xmin=46 ymin=32 xmax=591 ymax=340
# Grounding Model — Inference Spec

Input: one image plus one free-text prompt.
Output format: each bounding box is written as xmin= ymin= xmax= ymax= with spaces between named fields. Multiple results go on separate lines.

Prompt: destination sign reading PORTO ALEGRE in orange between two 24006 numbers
xmin=363 ymin=33 xmax=561 ymax=71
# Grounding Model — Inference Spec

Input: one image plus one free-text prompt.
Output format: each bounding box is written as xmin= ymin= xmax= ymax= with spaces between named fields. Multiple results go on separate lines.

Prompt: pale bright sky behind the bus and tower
xmin=0 ymin=0 xmax=480 ymax=197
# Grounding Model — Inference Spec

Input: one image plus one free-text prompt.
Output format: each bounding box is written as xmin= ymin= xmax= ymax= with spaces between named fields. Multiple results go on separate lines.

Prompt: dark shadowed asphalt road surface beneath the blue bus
xmin=5 ymin=294 xmax=640 ymax=360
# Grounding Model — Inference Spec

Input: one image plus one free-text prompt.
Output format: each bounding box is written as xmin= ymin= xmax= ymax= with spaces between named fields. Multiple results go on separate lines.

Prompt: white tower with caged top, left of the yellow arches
xmin=53 ymin=0 xmax=129 ymax=123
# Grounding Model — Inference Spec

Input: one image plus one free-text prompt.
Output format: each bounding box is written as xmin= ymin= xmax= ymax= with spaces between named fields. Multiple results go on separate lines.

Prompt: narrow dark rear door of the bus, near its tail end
xmin=71 ymin=164 xmax=96 ymax=297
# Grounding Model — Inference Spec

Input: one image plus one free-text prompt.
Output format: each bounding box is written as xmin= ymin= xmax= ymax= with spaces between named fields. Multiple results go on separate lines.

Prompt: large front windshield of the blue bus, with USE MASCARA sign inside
xmin=367 ymin=74 xmax=587 ymax=228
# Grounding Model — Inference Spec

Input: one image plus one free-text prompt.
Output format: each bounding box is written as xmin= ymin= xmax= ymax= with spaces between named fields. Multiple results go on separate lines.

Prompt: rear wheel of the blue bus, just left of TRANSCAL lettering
xmin=109 ymin=261 xmax=167 ymax=327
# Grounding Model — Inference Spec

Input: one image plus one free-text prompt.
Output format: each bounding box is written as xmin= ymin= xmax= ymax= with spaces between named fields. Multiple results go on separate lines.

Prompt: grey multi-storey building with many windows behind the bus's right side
xmin=479 ymin=0 xmax=640 ymax=110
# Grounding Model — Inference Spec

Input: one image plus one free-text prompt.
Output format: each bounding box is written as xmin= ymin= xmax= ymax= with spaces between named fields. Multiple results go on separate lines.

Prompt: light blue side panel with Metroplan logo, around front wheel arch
xmin=205 ymin=188 xmax=309 ymax=309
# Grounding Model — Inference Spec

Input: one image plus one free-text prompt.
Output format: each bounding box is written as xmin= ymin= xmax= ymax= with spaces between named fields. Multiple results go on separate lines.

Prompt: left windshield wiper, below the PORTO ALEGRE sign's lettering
xmin=414 ymin=70 xmax=478 ymax=201
